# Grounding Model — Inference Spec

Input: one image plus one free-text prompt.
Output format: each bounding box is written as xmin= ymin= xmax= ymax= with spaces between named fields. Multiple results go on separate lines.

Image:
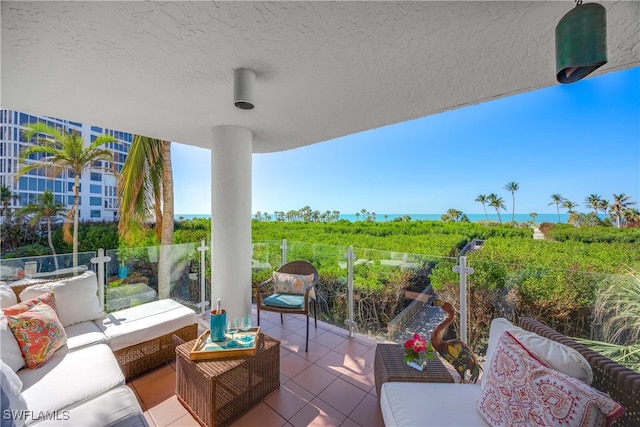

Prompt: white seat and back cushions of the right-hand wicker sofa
xmin=380 ymin=319 xmax=620 ymax=427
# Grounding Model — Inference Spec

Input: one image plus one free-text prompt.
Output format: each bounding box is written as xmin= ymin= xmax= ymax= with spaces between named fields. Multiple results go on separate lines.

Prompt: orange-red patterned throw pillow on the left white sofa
xmin=7 ymin=303 xmax=67 ymax=369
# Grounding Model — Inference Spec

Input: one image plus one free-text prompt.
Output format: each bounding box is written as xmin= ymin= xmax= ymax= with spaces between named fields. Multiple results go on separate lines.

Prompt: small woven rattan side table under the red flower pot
xmin=373 ymin=344 xmax=454 ymax=398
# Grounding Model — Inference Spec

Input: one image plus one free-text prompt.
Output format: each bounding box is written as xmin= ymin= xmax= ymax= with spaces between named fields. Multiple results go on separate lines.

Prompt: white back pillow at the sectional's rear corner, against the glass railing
xmin=20 ymin=271 xmax=105 ymax=326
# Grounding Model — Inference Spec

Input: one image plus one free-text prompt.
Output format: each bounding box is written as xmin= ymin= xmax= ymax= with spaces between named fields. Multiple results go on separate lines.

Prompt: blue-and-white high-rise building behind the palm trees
xmin=0 ymin=109 xmax=133 ymax=221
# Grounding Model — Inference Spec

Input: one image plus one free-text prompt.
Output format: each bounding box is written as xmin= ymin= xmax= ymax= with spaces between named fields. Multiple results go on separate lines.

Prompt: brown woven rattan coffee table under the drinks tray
xmin=176 ymin=334 xmax=280 ymax=427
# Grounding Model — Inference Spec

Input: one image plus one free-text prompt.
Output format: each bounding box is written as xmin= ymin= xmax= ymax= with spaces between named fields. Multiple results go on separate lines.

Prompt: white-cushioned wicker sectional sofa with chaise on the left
xmin=0 ymin=272 xmax=197 ymax=427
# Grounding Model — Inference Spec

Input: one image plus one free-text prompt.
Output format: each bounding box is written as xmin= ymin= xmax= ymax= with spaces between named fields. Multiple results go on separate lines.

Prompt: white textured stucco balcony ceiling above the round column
xmin=0 ymin=0 xmax=640 ymax=152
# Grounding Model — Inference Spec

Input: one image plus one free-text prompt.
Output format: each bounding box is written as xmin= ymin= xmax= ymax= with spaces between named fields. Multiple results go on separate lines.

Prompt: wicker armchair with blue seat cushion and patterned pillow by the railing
xmin=255 ymin=261 xmax=318 ymax=352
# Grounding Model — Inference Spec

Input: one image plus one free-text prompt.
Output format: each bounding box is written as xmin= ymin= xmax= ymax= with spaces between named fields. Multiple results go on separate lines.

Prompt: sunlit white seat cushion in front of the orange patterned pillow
xmin=18 ymin=344 xmax=124 ymax=424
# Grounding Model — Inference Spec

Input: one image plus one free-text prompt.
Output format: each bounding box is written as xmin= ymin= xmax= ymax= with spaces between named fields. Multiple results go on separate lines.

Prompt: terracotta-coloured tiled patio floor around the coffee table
xmin=128 ymin=308 xmax=384 ymax=427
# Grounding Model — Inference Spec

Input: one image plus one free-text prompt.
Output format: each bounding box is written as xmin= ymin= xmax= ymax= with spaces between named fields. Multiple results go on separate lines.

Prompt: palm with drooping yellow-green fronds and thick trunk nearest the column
xmin=118 ymin=135 xmax=173 ymax=299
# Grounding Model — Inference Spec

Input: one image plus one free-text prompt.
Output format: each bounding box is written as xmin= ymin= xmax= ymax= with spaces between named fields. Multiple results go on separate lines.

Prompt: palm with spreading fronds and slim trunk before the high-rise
xmin=18 ymin=122 xmax=116 ymax=267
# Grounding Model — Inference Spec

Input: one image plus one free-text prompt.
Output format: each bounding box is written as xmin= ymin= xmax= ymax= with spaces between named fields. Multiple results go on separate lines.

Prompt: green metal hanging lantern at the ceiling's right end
xmin=556 ymin=3 xmax=607 ymax=83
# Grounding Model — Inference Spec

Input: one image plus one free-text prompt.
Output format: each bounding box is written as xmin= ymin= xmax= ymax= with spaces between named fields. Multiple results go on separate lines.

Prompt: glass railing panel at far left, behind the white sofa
xmin=0 ymin=252 xmax=96 ymax=284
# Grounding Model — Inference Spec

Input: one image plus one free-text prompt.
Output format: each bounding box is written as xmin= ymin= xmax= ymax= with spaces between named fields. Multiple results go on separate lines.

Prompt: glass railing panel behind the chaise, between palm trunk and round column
xmin=105 ymin=243 xmax=205 ymax=312
